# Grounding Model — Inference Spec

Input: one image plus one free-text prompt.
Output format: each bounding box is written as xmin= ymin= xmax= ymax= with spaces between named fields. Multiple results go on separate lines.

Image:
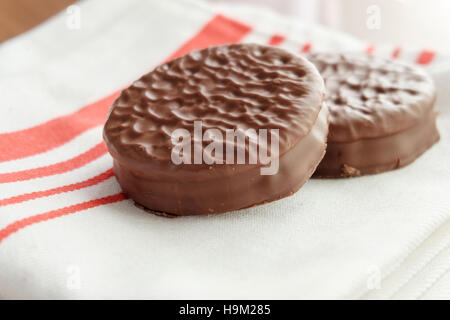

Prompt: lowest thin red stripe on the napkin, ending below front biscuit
xmin=0 ymin=193 xmax=126 ymax=242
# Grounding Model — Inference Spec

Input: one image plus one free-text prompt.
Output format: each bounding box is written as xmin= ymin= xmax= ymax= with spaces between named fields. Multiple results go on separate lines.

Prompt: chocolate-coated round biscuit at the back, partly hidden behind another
xmin=308 ymin=53 xmax=439 ymax=178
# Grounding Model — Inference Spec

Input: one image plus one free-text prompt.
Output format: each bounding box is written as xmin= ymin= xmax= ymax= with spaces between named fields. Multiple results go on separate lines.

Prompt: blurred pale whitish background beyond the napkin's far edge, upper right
xmin=208 ymin=0 xmax=450 ymax=51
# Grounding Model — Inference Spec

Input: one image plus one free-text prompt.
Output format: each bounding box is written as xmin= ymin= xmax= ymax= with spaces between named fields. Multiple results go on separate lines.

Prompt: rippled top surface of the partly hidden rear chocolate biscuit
xmin=308 ymin=53 xmax=436 ymax=142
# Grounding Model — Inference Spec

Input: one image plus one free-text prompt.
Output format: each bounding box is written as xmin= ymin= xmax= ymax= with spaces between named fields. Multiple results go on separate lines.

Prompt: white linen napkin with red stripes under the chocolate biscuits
xmin=0 ymin=0 xmax=450 ymax=299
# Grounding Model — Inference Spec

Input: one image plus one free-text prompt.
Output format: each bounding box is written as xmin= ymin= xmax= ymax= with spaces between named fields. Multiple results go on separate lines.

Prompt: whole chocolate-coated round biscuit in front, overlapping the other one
xmin=103 ymin=44 xmax=328 ymax=216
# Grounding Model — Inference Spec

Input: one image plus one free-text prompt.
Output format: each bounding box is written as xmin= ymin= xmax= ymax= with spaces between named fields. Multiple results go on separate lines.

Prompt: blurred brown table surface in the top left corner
xmin=0 ymin=0 xmax=75 ymax=42
